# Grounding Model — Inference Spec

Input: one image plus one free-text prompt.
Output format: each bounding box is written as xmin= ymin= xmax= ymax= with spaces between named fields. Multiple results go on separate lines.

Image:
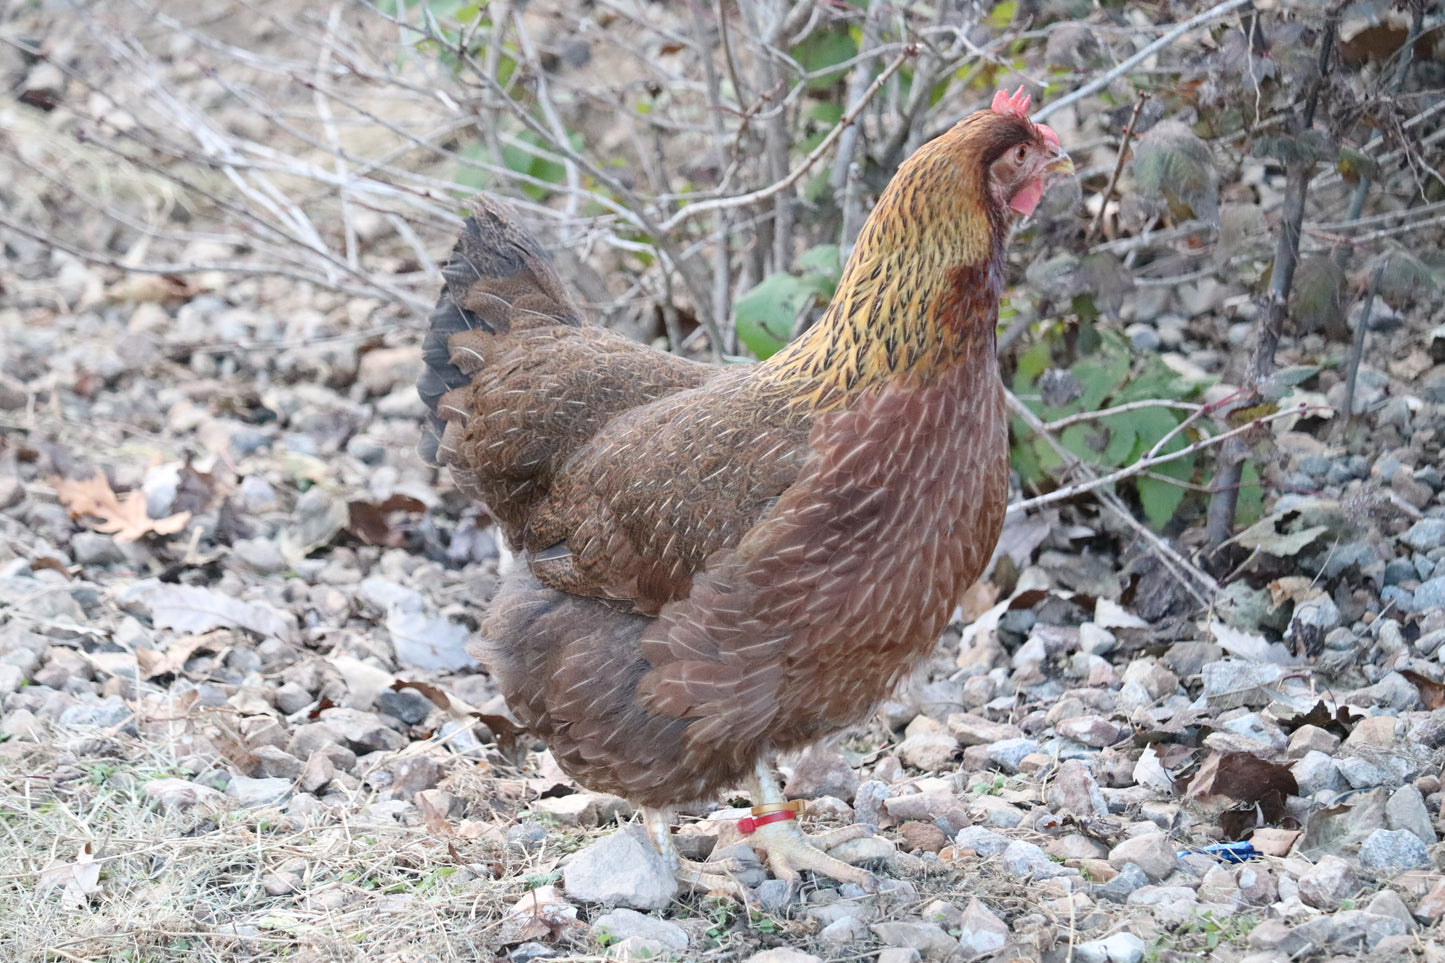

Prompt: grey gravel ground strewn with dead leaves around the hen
xmin=0 ymin=1 xmax=1445 ymax=963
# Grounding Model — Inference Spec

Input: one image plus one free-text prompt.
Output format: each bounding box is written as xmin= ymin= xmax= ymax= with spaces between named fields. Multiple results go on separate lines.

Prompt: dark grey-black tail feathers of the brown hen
xmin=416 ymin=195 xmax=582 ymax=464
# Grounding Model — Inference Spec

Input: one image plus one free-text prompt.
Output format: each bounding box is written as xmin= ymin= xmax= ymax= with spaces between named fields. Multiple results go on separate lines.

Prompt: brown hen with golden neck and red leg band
xmin=419 ymin=91 xmax=1072 ymax=885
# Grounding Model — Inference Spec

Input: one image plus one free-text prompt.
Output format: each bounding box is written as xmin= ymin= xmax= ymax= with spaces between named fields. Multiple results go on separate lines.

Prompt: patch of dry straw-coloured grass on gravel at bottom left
xmin=0 ymin=735 xmax=537 ymax=962
